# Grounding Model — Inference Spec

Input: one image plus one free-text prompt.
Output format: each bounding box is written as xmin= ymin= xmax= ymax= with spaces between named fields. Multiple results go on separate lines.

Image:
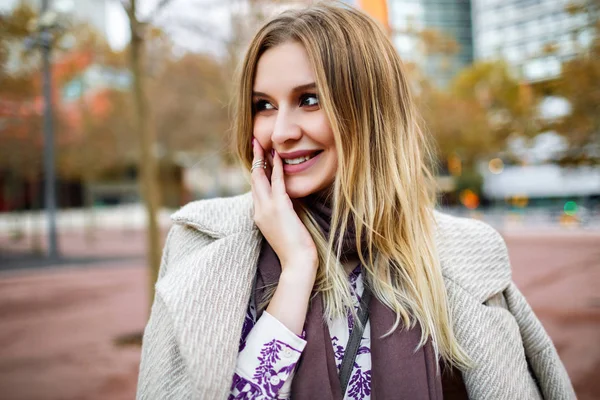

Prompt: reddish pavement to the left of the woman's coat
xmin=0 ymin=263 xmax=148 ymax=400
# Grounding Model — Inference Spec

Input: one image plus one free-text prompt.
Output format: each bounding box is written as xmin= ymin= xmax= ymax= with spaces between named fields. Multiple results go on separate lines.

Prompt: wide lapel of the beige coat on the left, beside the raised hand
xmin=156 ymin=195 xmax=262 ymax=398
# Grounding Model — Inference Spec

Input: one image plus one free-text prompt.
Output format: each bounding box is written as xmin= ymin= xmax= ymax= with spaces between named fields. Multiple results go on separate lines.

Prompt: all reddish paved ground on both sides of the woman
xmin=0 ymin=230 xmax=600 ymax=400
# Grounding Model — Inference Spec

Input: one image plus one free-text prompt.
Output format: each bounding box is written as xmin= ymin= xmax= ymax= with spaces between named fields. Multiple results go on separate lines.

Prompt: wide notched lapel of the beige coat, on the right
xmin=436 ymin=213 xmax=540 ymax=400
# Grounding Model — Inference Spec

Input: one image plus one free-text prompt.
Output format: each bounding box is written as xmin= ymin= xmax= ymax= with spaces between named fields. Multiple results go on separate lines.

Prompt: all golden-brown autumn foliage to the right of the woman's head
xmin=418 ymin=0 xmax=600 ymax=170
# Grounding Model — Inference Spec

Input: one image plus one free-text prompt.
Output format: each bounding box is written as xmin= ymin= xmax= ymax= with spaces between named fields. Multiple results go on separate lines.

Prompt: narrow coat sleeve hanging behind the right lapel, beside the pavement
xmin=503 ymin=283 xmax=576 ymax=400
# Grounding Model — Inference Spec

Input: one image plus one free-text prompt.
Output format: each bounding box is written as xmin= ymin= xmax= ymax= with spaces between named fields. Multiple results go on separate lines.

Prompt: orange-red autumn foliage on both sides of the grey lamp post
xmin=0 ymin=1 xmax=131 ymax=180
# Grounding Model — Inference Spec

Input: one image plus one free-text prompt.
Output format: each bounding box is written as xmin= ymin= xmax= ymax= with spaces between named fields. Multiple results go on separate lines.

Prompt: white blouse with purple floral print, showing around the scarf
xmin=229 ymin=267 xmax=371 ymax=400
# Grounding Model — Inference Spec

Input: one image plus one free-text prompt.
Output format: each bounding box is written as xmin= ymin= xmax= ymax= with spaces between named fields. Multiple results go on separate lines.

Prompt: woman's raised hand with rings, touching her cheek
xmin=251 ymin=139 xmax=318 ymax=279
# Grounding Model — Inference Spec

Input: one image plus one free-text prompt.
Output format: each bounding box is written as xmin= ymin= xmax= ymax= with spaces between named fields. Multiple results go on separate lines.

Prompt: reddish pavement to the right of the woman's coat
xmin=506 ymin=233 xmax=600 ymax=400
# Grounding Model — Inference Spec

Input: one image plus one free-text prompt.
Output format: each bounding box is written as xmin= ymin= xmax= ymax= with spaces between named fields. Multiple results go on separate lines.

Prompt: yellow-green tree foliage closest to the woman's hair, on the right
xmin=411 ymin=31 xmax=538 ymax=175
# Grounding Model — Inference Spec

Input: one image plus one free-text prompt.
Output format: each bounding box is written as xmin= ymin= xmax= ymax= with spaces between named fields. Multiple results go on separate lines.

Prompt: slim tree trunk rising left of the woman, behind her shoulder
xmin=127 ymin=0 xmax=162 ymax=304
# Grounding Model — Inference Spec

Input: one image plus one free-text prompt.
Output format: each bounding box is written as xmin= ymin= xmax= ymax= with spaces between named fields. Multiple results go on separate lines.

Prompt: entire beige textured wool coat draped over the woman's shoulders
xmin=137 ymin=194 xmax=575 ymax=400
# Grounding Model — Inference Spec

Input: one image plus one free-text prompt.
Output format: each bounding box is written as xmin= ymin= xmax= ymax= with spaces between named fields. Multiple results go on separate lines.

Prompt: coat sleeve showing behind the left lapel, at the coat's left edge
xmin=136 ymin=228 xmax=192 ymax=400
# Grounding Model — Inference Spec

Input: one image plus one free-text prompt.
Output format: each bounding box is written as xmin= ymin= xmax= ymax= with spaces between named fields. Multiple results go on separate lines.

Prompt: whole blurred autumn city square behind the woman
xmin=0 ymin=0 xmax=600 ymax=400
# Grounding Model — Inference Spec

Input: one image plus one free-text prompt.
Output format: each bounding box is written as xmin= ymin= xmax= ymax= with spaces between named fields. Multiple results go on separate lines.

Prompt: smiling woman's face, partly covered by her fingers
xmin=252 ymin=42 xmax=337 ymax=198
